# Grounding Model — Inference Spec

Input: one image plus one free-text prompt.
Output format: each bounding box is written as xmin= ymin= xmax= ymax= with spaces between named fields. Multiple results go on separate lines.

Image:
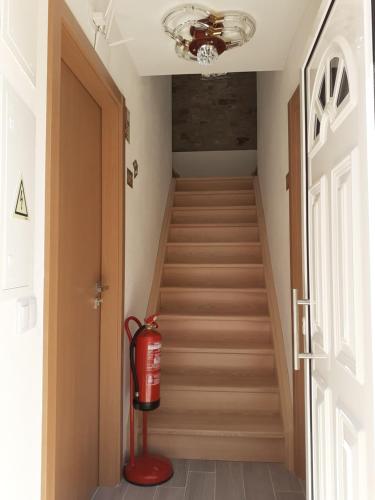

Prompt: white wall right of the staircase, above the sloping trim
xmin=258 ymin=0 xmax=322 ymax=377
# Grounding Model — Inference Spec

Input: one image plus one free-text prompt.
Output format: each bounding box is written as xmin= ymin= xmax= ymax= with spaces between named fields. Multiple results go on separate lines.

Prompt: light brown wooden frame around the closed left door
xmin=42 ymin=0 xmax=125 ymax=500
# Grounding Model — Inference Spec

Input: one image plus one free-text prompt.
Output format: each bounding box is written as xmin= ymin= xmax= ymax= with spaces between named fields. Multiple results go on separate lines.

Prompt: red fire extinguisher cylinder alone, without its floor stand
xmin=128 ymin=315 xmax=161 ymax=411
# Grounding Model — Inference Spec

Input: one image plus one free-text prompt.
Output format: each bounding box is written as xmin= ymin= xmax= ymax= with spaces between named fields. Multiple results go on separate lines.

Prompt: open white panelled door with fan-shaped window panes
xmin=305 ymin=0 xmax=375 ymax=500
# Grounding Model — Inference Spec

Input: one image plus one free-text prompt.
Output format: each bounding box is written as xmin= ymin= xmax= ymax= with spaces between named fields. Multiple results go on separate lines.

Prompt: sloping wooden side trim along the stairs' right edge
xmin=254 ymin=177 xmax=293 ymax=469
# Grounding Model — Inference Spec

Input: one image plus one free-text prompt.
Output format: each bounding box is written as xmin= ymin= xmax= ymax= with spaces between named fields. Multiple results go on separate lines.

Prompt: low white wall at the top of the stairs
xmin=173 ymin=150 xmax=257 ymax=177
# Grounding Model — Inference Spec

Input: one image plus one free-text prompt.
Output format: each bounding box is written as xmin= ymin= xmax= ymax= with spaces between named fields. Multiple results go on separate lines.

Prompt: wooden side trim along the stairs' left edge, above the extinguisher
xmin=147 ymin=178 xmax=176 ymax=315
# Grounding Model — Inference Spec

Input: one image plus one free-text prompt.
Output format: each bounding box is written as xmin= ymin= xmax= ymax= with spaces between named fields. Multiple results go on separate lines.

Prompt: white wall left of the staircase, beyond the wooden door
xmin=67 ymin=0 xmax=172 ymax=460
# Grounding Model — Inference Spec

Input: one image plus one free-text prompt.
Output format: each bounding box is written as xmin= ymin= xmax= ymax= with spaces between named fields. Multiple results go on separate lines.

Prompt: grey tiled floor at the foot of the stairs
xmin=92 ymin=460 xmax=305 ymax=500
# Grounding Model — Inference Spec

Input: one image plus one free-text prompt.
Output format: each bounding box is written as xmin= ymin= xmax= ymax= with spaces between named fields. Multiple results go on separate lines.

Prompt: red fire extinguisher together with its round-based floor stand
xmin=124 ymin=315 xmax=173 ymax=486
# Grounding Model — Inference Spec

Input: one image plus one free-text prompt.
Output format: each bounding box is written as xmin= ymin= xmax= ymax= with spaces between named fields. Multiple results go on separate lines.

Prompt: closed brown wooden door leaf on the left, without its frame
xmin=56 ymin=62 xmax=102 ymax=500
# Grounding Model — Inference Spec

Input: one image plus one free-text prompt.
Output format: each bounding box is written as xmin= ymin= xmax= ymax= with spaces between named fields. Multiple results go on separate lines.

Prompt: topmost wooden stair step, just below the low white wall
xmin=176 ymin=177 xmax=253 ymax=192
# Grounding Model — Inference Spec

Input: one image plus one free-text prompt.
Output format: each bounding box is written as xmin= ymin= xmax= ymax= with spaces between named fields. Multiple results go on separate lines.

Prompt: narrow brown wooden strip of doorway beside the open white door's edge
xmin=288 ymin=87 xmax=306 ymax=479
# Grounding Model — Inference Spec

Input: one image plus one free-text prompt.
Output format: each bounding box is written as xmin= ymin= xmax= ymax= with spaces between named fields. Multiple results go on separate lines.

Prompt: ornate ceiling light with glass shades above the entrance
xmin=162 ymin=4 xmax=256 ymax=65
